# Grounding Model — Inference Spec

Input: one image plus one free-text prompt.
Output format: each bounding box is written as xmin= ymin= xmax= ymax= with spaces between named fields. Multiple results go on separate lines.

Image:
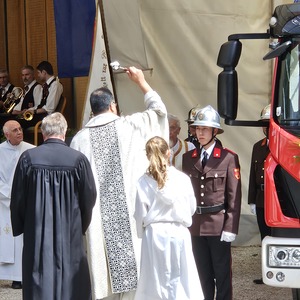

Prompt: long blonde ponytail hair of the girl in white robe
xmin=146 ymin=136 xmax=169 ymax=189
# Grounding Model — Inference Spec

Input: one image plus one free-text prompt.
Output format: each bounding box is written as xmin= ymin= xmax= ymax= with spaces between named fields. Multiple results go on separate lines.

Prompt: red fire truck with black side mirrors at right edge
xmin=217 ymin=3 xmax=300 ymax=299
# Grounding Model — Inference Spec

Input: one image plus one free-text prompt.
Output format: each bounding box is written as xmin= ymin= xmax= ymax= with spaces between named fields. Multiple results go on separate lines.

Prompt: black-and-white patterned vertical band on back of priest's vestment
xmin=90 ymin=122 xmax=137 ymax=293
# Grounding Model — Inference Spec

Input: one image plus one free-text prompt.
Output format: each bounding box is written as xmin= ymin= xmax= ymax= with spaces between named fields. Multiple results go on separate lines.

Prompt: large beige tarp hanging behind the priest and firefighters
xmin=99 ymin=0 xmax=291 ymax=245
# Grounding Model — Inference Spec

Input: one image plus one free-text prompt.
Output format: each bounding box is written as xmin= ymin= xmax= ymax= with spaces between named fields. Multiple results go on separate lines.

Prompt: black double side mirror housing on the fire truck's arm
xmin=217 ymin=40 xmax=242 ymax=120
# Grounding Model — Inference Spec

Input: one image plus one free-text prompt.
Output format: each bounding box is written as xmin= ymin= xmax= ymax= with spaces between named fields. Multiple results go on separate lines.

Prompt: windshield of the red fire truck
xmin=273 ymin=39 xmax=300 ymax=136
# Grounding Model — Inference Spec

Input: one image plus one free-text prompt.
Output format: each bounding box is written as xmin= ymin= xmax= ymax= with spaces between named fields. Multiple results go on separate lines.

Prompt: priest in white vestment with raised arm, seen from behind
xmin=71 ymin=67 xmax=169 ymax=300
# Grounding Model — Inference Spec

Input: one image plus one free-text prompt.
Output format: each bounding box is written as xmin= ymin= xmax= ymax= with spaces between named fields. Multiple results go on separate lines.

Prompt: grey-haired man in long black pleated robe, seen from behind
xmin=11 ymin=113 xmax=96 ymax=300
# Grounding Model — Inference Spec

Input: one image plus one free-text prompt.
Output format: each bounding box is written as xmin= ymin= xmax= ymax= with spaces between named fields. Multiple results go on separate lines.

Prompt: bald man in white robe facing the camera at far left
xmin=0 ymin=120 xmax=34 ymax=288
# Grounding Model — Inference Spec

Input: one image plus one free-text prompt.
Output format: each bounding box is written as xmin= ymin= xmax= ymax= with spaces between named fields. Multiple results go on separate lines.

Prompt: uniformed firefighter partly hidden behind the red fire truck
xmin=248 ymin=105 xmax=271 ymax=284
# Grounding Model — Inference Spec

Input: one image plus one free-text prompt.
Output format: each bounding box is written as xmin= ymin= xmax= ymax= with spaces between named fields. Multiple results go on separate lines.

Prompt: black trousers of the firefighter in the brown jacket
xmin=192 ymin=236 xmax=232 ymax=300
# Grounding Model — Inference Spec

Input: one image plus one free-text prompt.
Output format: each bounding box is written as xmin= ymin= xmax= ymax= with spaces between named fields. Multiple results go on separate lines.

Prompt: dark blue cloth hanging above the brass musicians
xmin=54 ymin=0 xmax=96 ymax=78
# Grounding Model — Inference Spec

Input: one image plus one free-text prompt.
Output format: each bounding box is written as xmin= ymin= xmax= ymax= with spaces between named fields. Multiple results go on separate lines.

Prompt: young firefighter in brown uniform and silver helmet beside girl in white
xmin=183 ymin=105 xmax=241 ymax=300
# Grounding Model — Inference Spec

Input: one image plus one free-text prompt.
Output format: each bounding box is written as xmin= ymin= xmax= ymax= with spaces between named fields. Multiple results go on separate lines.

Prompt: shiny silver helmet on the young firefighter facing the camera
xmin=191 ymin=105 xmax=224 ymax=134
